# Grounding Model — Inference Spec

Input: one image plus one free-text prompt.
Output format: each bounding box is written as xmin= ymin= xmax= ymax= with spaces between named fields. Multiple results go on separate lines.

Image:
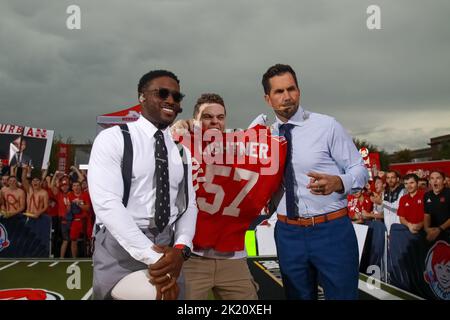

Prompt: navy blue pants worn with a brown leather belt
xmin=275 ymin=216 xmax=359 ymax=300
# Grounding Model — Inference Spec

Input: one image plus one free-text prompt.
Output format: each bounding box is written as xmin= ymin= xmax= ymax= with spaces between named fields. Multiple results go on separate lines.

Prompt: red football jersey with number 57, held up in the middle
xmin=178 ymin=125 xmax=287 ymax=252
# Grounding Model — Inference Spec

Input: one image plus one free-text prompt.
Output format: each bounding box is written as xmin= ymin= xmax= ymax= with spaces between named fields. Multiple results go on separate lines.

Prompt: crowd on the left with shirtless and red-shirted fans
xmin=0 ymin=164 xmax=95 ymax=258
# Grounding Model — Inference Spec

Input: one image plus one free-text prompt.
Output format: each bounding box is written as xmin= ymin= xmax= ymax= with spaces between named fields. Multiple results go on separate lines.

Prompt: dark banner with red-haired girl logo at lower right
xmin=388 ymin=224 xmax=450 ymax=300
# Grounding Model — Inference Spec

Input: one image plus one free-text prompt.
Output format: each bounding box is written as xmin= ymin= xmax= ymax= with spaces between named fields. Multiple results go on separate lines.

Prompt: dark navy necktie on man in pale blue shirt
xmin=280 ymin=123 xmax=298 ymax=218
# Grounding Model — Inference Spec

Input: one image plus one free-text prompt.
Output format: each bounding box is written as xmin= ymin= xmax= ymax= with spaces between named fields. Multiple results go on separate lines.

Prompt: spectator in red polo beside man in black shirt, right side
xmin=397 ymin=173 xmax=425 ymax=234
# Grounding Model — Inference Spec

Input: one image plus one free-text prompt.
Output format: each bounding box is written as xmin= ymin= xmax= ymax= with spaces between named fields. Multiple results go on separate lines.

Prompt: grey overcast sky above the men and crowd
xmin=0 ymin=0 xmax=450 ymax=152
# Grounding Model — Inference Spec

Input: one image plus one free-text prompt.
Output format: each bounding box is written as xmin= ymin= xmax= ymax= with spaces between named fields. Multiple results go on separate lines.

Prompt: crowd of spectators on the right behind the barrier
xmin=348 ymin=171 xmax=450 ymax=242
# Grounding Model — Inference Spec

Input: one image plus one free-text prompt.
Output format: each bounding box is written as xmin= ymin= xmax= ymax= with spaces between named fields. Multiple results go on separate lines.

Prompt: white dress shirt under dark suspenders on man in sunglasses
xmin=88 ymin=116 xmax=197 ymax=265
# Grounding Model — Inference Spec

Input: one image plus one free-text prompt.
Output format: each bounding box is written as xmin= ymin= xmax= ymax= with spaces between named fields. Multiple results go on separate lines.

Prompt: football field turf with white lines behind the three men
xmin=0 ymin=257 xmax=420 ymax=300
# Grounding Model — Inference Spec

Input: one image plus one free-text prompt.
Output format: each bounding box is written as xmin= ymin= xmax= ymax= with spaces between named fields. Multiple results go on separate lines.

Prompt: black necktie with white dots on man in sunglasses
xmin=155 ymin=130 xmax=170 ymax=232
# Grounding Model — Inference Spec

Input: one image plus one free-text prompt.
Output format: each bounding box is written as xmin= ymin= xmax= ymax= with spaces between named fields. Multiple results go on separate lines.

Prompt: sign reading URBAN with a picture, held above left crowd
xmin=0 ymin=124 xmax=53 ymax=169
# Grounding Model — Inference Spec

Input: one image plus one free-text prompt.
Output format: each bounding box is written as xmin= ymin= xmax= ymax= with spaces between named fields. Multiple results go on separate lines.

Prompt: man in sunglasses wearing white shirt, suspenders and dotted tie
xmin=88 ymin=70 xmax=197 ymax=300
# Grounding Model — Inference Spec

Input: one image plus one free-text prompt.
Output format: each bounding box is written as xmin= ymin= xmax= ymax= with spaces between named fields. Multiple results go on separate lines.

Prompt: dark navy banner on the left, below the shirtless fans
xmin=0 ymin=215 xmax=52 ymax=258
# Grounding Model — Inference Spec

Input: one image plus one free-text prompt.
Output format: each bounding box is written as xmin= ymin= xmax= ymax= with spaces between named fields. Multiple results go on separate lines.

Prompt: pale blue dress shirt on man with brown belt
xmin=273 ymin=106 xmax=369 ymax=217
